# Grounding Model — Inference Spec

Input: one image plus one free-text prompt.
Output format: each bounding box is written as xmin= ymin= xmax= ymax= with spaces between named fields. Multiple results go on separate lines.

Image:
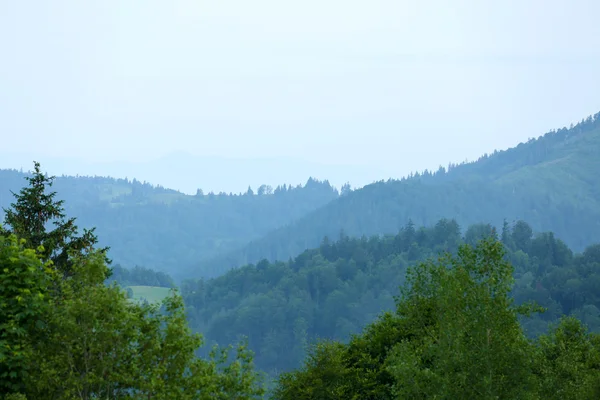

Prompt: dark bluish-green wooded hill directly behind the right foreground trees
xmin=181 ymin=220 xmax=600 ymax=375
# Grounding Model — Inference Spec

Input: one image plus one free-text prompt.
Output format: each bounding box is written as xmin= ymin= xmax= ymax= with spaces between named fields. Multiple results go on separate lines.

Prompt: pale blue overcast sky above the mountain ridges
xmin=0 ymin=0 xmax=600 ymax=192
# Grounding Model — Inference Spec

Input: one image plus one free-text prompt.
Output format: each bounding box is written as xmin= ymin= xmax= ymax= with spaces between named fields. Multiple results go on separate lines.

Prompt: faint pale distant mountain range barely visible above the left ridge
xmin=0 ymin=150 xmax=392 ymax=194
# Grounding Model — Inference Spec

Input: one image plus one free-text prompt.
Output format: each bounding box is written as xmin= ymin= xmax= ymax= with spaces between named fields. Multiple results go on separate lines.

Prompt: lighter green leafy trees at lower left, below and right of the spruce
xmin=26 ymin=254 xmax=261 ymax=400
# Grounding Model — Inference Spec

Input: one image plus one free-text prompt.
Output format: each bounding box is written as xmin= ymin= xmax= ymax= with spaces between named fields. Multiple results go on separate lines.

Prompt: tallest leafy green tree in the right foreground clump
xmin=386 ymin=239 xmax=531 ymax=399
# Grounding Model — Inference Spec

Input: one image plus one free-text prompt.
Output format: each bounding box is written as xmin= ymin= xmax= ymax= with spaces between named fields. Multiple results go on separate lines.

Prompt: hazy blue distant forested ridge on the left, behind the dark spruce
xmin=0 ymin=170 xmax=338 ymax=278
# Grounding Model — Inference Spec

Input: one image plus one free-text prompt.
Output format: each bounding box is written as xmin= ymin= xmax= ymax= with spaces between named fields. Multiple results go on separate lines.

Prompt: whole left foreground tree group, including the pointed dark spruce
xmin=0 ymin=164 xmax=264 ymax=400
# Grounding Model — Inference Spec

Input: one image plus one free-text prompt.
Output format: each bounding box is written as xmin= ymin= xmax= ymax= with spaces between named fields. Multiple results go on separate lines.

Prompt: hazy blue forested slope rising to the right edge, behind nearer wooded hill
xmin=203 ymin=113 xmax=600 ymax=275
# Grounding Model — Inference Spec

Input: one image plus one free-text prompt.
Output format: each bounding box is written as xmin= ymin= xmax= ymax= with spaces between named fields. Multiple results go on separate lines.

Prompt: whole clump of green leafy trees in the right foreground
xmin=273 ymin=238 xmax=600 ymax=400
